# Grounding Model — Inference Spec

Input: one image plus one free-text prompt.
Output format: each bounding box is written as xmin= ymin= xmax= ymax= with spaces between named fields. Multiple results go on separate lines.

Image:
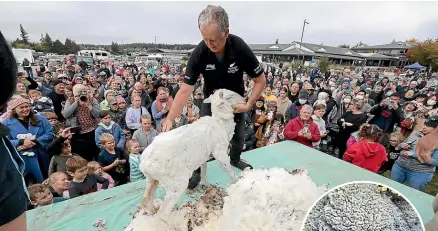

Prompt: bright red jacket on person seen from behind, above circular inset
xmin=343 ymin=139 xmax=388 ymax=172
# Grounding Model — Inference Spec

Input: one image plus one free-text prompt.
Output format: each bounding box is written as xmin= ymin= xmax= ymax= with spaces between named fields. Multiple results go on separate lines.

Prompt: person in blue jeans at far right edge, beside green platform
xmin=391 ymin=116 xmax=438 ymax=191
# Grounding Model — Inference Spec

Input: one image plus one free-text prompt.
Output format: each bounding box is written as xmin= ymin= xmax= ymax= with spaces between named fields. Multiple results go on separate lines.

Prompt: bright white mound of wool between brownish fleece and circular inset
xmin=195 ymin=168 xmax=327 ymax=231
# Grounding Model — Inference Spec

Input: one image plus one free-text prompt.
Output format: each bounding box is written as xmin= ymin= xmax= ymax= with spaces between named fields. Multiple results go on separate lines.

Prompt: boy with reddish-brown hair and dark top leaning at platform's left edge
xmin=66 ymin=156 xmax=109 ymax=198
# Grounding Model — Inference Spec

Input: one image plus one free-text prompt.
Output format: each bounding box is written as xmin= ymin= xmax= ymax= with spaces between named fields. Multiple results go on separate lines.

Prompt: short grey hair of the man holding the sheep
xmin=198 ymin=5 xmax=230 ymax=33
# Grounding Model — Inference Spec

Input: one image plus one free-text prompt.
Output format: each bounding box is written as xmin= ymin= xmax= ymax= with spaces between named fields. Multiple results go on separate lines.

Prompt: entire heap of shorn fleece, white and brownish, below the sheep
xmin=125 ymin=168 xmax=327 ymax=231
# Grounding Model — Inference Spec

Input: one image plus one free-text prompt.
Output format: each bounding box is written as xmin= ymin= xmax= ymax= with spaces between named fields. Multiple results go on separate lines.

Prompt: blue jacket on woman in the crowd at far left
xmin=2 ymin=115 xmax=53 ymax=170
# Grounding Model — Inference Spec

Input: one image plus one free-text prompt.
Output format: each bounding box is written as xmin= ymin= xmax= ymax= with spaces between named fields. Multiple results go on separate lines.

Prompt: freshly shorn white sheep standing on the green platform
xmin=140 ymin=89 xmax=245 ymax=217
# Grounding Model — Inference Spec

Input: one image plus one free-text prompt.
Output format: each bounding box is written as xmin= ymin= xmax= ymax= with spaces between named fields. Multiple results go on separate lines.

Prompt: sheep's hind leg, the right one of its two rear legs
xmin=157 ymin=179 xmax=189 ymax=219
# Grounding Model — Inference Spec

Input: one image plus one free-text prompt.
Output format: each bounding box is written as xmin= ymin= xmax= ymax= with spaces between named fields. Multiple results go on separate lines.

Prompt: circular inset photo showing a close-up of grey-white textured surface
xmin=302 ymin=181 xmax=424 ymax=231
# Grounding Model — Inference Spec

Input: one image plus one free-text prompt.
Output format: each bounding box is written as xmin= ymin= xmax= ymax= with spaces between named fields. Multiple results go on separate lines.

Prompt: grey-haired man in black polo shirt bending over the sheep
xmin=162 ymin=5 xmax=265 ymax=188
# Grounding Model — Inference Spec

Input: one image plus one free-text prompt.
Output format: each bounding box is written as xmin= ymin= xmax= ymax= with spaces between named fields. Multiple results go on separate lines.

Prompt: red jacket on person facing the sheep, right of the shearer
xmin=283 ymin=116 xmax=321 ymax=147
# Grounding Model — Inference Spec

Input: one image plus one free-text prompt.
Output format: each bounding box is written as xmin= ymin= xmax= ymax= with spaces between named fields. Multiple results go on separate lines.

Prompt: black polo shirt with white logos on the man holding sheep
xmin=184 ymin=34 xmax=263 ymax=98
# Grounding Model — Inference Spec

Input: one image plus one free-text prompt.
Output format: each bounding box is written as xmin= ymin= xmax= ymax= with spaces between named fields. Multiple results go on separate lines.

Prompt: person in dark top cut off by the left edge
xmin=0 ymin=32 xmax=29 ymax=231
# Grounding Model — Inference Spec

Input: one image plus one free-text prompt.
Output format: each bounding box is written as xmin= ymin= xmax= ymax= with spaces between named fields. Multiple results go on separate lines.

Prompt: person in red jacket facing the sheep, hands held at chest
xmin=283 ymin=105 xmax=321 ymax=147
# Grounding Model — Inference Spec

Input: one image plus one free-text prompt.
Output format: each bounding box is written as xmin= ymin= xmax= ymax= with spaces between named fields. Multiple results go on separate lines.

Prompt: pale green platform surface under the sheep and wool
xmin=27 ymin=141 xmax=433 ymax=231
